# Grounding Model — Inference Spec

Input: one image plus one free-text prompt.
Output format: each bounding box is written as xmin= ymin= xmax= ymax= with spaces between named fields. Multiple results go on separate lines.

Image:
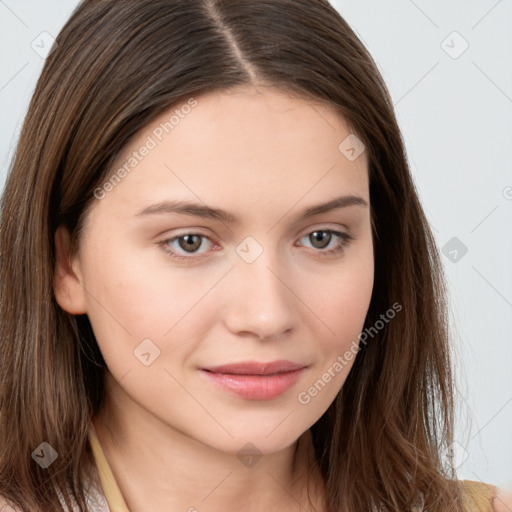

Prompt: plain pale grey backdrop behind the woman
xmin=0 ymin=0 xmax=512 ymax=489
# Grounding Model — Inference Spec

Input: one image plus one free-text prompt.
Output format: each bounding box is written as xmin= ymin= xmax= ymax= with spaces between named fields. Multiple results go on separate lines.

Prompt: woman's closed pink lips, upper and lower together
xmin=201 ymin=360 xmax=306 ymax=400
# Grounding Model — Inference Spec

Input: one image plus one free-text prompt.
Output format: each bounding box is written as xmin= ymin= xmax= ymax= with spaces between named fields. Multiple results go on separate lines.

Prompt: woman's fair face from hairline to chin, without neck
xmin=56 ymin=87 xmax=374 ymax=453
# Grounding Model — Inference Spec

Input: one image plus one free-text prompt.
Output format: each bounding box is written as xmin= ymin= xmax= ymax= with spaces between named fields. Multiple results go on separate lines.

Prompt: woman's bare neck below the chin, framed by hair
xmin=93 ymin=372 xmax=323 ymax=512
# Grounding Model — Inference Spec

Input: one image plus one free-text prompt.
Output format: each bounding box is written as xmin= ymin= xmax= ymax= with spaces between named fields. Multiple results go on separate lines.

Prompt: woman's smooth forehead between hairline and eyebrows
xmin=89 ymin=86 xmax=368 ymax=220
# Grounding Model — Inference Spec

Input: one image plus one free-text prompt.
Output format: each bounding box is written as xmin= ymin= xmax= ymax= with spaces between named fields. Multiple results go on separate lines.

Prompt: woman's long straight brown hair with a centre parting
xmin=0 ymin=0 xmax=462 ymax=512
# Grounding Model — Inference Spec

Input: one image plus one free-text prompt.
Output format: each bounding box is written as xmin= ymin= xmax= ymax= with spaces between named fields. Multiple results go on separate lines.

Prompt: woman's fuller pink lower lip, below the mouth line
xmin=201 ymin=368 xmax=305 ymax=400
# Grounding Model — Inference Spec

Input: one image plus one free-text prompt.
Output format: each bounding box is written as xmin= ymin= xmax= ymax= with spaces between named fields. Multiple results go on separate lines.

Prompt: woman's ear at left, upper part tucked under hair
xmin=53 ymin=226 xmax=87 ymax=315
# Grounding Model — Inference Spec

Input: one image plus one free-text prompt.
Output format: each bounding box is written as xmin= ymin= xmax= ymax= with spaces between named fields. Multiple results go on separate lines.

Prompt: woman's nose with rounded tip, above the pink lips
xmin=223 ymin=250 xmax=300 ymax=340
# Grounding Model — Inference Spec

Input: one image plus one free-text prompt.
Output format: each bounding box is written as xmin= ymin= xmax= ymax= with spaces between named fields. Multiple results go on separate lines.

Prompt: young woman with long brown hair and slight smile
xmin=0 ymin=0 xmax=510 ymax=512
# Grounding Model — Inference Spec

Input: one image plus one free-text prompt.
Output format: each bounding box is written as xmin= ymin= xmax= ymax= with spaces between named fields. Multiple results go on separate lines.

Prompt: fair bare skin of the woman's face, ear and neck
xmin=55 ymin=86 xmax=374 ymax=512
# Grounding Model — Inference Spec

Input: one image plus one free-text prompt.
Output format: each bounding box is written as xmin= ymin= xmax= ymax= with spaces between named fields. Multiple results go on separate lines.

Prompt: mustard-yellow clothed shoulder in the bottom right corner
xmin=461 ymin=480 xmax=512 ymax=512
